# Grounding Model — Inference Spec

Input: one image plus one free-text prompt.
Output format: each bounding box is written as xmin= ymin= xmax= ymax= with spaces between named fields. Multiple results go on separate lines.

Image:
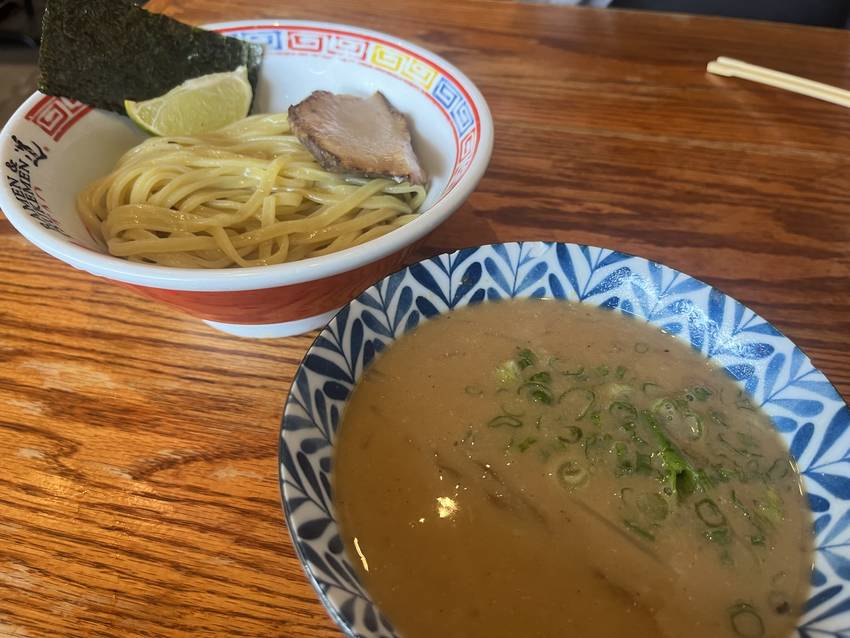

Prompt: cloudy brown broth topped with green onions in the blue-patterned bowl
xmin=335 ymin=301 xmax=812 ymax=638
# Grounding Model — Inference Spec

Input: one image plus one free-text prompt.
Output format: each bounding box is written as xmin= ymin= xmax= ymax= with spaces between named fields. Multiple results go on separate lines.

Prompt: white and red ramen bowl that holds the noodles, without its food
xmin=0 ymin=20 xmax=493 ymax=337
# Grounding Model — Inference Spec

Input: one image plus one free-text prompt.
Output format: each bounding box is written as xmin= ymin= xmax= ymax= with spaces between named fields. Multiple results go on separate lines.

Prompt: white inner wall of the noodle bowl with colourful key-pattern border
xmin=0 ymin=21 xmax=486 ymax=252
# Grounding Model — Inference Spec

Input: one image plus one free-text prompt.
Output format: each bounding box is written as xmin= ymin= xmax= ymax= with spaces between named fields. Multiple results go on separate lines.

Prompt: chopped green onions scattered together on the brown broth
xmin=464 ymin=342 xmax=795 ymax=564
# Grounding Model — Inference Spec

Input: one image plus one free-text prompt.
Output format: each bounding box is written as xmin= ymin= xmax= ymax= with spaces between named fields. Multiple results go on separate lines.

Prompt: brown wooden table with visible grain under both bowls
xmin=0 ymin=0 xmax=850 ymax=638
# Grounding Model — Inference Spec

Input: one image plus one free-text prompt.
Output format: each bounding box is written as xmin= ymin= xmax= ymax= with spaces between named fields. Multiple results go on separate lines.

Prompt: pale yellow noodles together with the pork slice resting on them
xmin=77 ymin=91 xmax=427 ymax=268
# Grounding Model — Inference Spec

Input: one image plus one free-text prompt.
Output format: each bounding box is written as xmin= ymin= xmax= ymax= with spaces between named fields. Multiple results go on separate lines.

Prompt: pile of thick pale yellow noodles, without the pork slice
xmin=77 ymin=113 xmax=427 ymax=268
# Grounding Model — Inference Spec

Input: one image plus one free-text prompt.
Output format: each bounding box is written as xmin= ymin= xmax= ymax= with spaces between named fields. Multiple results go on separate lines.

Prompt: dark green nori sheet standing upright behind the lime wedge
xmin=38 ymin=0 xmax=263 ymax=113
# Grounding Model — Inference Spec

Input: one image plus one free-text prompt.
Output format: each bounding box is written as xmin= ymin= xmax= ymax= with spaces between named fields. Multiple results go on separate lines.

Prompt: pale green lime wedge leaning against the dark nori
xmin=124 ymin=66 xmax=252 ymax=136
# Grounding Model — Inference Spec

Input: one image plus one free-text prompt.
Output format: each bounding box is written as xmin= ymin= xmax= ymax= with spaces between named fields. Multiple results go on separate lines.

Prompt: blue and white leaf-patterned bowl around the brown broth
xmin=280 ymin=242 xmax=850 ymax=638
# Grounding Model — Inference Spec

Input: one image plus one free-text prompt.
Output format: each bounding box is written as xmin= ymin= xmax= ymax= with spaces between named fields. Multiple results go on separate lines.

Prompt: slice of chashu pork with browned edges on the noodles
xmin=289 ymin=91 xmax=427 ymax=184
